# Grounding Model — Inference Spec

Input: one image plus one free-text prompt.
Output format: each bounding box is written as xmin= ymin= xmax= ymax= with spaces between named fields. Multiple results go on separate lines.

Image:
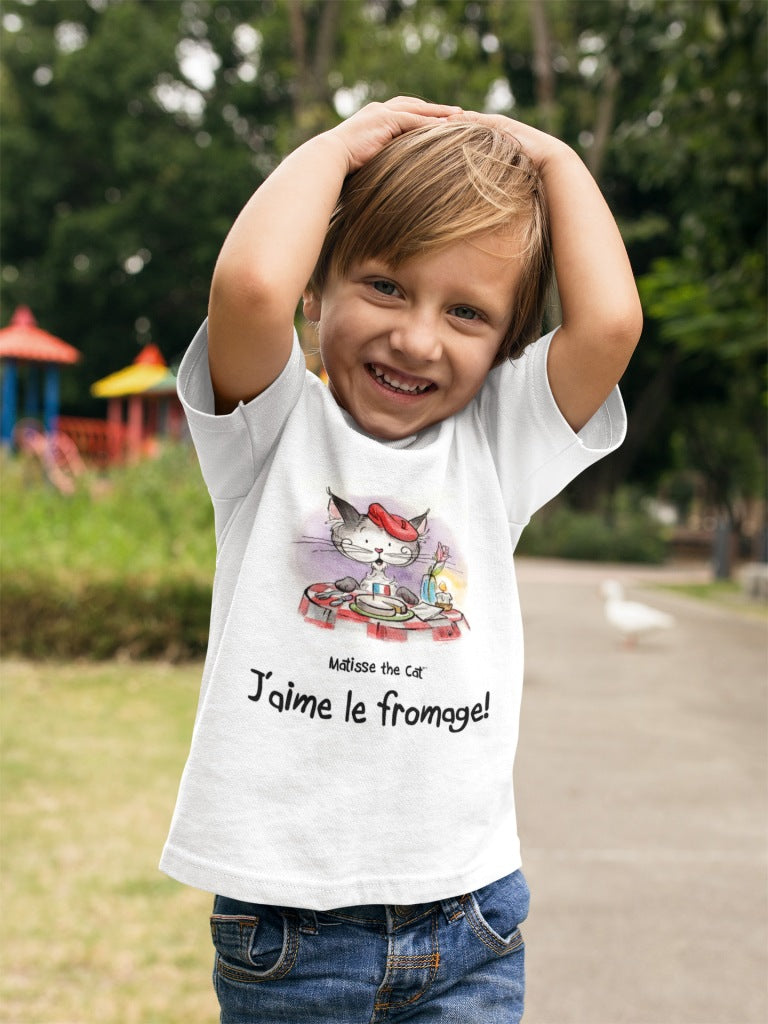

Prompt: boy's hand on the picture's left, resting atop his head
xmin=326 ymin=96 xmax=461 ymax=173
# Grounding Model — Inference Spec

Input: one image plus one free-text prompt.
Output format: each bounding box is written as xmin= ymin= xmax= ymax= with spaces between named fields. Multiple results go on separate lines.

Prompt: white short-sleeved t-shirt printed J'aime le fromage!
xmin=161 ymin=325 xmax=626 ymax=909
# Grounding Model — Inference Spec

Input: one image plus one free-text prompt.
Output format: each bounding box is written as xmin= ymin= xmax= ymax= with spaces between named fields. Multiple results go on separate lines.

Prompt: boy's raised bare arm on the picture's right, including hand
xmin=456 ymin=115 xmax=643 ymax=431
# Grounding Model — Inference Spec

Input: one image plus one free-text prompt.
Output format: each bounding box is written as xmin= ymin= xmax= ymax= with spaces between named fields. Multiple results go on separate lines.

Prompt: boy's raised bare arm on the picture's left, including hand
xmin=208 ymin=97 xmax=458 ymax=413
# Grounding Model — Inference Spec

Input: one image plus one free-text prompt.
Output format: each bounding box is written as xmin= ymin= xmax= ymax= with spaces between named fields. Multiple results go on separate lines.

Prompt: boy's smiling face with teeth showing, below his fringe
xmin=304 ymin=232 xmax=522 ymax=440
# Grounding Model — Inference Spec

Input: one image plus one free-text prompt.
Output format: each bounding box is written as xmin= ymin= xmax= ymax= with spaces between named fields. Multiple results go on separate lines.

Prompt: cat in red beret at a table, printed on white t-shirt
xmin=299 ymin=487 xmax=469 ymax=643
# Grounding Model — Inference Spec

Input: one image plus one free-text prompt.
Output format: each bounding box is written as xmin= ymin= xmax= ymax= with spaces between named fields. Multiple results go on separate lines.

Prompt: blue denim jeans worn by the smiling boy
xmin=211 ymin=871 xmax=528 ymax=1024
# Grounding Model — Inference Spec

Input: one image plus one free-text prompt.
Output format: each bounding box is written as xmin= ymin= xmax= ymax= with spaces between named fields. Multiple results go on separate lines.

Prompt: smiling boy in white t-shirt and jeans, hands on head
xmin=161 ymin=97 xmax=641 ymax=1024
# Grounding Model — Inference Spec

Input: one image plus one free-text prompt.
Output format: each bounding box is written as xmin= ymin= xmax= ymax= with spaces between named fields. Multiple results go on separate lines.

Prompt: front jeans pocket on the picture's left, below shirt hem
xmin=211 ymin=897 xmax=299 ymax=984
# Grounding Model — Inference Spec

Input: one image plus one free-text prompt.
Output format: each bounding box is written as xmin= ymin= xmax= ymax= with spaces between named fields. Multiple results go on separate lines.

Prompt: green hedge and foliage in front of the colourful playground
xmin=0 ymin=446 xmax=215 ymax=660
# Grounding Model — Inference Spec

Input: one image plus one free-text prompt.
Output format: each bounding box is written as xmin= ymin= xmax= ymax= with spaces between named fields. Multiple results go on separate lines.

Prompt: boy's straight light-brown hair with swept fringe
xmin=308 ymin=121 xmax=552 ymax=366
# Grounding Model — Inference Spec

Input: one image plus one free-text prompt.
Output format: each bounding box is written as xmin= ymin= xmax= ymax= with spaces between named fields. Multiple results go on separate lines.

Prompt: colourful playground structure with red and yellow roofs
xmin=0 ymin=306 xmax=183 ymax=494
